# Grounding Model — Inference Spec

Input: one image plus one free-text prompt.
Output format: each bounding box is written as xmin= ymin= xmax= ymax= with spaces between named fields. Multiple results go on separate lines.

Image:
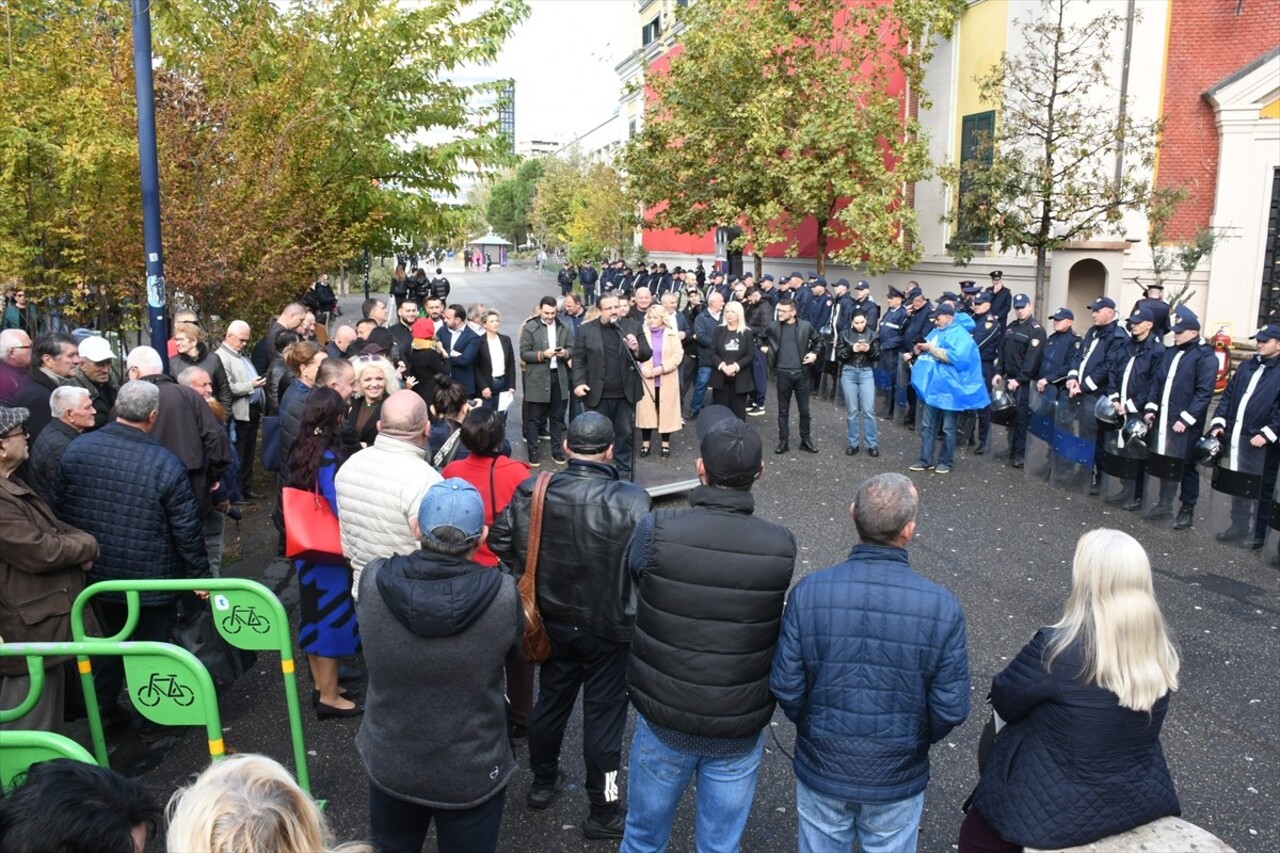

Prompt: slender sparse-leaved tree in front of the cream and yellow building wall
xmin=945 ymin=0 xmax=1160 ymax=311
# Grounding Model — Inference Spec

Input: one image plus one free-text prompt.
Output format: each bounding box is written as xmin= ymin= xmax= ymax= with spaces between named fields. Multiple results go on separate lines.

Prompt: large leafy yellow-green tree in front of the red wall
xmin=625 ymin=0 xmax=964 ymax=272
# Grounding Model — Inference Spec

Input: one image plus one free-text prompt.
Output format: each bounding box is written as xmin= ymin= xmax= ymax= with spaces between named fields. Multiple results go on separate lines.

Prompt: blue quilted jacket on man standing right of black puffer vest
xmin=769 ymin=544 xmax=969 ymax=803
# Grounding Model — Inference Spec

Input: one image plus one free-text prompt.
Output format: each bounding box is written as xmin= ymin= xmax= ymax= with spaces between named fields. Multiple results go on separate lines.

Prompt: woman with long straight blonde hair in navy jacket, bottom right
xmin=960 ymin=529 xmax=1181 ymax=853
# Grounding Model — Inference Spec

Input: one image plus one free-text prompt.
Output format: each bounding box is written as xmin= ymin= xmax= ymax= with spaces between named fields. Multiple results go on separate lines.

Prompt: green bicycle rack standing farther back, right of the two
xmin=72 ymin=578 xmax=311 ymax=794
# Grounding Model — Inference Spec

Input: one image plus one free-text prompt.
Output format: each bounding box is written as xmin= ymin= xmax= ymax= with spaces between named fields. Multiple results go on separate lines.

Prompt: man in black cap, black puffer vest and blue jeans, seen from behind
xmin=621 ymin=406 xmax=796 ymax=853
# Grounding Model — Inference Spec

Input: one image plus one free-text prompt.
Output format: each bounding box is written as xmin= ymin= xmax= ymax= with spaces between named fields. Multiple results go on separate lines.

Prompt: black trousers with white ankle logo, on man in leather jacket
xmin=529 ymin=620 xmax=630 ymax=817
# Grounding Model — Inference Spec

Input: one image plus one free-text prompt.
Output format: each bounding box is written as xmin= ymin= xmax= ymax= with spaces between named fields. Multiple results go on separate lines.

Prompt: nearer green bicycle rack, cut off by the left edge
xmin=0 ymin=639 xmax=227 ymax=775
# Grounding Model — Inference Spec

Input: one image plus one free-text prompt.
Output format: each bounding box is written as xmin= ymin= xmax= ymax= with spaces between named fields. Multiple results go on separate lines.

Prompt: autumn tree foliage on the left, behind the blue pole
xmin=0 ymin=0 xmax=527 ymax=328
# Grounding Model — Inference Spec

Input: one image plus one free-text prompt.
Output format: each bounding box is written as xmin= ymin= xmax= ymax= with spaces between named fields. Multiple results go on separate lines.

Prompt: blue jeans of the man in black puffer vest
xmin=620 ymin=715 xmax=764 ymax=853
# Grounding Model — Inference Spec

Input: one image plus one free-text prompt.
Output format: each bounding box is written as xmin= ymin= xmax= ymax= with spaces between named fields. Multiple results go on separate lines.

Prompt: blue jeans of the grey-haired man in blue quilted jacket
xmin=796 ymin=780 xmax=924 ymax=853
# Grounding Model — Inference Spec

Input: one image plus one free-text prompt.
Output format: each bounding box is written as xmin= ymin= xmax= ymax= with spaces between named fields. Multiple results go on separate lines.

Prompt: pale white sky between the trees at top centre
xmin=485 ymin=0 xmax=640 ymax=142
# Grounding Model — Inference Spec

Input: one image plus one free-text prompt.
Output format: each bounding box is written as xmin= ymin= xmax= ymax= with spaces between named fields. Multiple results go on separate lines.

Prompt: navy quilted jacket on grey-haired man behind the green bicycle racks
xmin=50 ymin=423 xmax=209 ymax=605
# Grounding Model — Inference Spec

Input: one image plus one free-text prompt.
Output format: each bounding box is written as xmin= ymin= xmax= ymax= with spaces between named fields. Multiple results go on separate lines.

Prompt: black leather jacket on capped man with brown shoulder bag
xmin=489 ymin=459 xmax=653 ymax=643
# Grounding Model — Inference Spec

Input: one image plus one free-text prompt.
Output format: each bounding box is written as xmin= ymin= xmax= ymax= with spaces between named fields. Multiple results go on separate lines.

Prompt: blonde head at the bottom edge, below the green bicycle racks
xmin=165 ymin=753 xmax=372 ymax=853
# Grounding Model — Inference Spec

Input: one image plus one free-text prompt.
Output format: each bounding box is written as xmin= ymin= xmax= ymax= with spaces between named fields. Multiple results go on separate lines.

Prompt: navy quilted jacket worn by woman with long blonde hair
xmin=973 ymin=628 xmax=1181 ymax=849
